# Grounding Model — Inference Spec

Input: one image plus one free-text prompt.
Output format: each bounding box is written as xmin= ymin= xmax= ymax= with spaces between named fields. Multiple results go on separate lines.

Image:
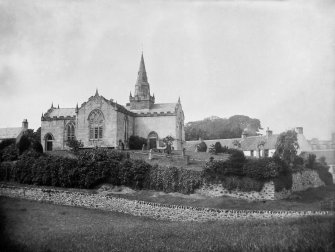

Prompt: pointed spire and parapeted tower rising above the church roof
xmin=129 ymin=53 xmax=155 ymax=110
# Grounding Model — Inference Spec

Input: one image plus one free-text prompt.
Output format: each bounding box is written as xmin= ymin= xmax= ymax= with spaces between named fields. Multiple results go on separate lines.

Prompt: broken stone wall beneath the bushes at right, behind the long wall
xmin=197 ymin=170 xmax=325 ymax=201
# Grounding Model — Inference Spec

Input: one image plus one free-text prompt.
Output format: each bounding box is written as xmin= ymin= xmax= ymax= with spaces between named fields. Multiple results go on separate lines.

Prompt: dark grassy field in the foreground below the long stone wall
xmin=0 ymin=197 xmax=335 ymax=251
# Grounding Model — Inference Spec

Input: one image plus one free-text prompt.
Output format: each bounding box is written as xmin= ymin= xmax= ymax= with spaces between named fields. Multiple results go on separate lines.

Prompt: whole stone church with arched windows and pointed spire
xmin=41 ymin=54 xmax=185 ymax=151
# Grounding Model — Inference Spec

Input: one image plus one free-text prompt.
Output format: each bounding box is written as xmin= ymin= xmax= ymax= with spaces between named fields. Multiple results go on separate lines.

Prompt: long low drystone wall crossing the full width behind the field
xmin=0 ymin=184 xmax=330 ymax=222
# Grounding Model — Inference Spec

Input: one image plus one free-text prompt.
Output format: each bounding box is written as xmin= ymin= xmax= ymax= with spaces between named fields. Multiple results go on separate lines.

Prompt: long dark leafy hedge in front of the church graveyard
xmin=0 ymin=149 xmax=202 ymax=193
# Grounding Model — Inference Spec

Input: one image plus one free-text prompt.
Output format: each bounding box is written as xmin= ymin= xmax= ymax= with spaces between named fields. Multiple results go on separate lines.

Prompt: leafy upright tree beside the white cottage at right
xmin=274 ymin=130 xmax=299 ymax=165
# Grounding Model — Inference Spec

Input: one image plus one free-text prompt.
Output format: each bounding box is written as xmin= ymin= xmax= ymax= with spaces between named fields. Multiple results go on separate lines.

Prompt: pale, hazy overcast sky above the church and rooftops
xmin=0 ymin=0 xmax=335 ymax=140
